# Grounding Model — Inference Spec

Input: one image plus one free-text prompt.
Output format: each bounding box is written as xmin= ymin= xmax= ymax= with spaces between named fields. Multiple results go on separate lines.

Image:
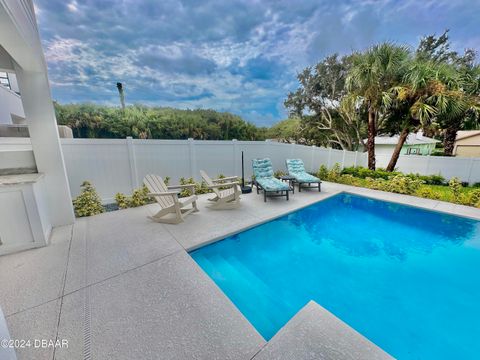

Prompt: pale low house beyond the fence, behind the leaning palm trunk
xmin=365 ymin=131 xmax=440 ymax=156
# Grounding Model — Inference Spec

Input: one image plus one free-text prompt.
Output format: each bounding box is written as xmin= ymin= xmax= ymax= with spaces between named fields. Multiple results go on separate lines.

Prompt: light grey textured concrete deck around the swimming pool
xmin=0 ymin=183 xmax=480 ymax=360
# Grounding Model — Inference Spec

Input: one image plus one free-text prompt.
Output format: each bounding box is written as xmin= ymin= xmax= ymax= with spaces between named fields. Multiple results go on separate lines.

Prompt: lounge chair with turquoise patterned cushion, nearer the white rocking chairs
xmin=252 ymin=158 xmax=292 ymax=202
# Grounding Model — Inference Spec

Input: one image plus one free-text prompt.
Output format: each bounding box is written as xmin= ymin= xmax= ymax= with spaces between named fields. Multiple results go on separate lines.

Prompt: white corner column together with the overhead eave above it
xmin=0 ymin=0 xmax=75 ymax=231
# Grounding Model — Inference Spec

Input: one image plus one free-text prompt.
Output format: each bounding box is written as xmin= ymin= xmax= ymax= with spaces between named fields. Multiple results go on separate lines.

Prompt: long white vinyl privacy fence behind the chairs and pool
xmin=0 ymin=138 xmax=480 ymax=203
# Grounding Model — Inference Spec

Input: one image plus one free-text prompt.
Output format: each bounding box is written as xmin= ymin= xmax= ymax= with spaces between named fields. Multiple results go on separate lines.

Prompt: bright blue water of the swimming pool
xmin=191 ymin=194 xmax=480 ymax=359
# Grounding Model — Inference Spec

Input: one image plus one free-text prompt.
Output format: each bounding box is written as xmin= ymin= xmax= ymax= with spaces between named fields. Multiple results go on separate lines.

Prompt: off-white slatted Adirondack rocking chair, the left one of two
xmin=143 ymin=175 xmax=198 ymax=224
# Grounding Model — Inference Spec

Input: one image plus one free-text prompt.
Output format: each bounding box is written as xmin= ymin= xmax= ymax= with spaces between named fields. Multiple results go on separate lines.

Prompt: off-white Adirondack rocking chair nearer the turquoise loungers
xmin=200 ymin=170 xmax=240 ymax=210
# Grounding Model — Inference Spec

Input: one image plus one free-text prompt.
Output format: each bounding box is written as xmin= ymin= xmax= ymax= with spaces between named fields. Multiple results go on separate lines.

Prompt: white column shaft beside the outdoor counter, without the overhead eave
xmin=15 ymin=65 xmax=75 ymax=226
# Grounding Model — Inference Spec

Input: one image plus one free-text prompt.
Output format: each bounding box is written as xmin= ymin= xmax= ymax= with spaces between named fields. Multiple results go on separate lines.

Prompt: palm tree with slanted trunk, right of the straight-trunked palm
xmin=383 ymin=60 xmax=465 ymax=171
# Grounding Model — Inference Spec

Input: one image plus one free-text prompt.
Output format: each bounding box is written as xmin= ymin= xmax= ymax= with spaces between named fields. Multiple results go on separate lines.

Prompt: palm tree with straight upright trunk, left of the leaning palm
xmin=347 ymin=43 xmax=409 ymax=170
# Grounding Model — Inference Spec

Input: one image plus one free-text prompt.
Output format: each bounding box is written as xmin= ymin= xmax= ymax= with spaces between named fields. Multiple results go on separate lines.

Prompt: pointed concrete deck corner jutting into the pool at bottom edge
xmin=252 ymin=301 xmax=393 ymax=360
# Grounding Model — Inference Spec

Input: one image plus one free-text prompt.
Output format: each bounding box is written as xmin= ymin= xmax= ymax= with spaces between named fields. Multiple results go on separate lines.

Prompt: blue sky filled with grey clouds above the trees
xmin=34 ymin=0 xmax=480 ymax=125
